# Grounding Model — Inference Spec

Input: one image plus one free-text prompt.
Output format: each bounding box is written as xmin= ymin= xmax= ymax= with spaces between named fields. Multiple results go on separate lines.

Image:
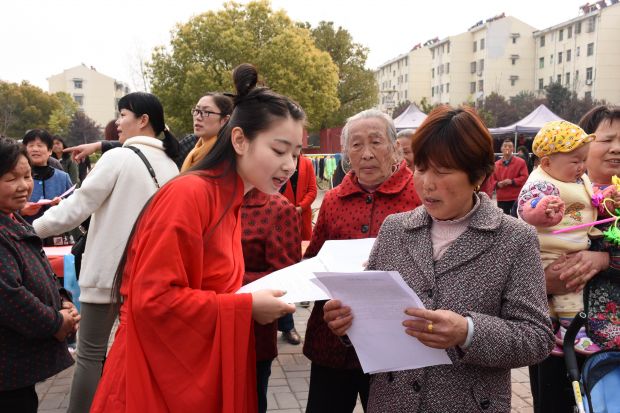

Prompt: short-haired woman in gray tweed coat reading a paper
xmin=324 ymin=106 xmax=554 ymax=413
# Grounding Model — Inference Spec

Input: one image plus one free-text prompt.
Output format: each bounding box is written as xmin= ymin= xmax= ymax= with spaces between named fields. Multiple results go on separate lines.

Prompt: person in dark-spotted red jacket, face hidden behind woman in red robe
xmin=241 ymin=189 xmax=301 ymax=413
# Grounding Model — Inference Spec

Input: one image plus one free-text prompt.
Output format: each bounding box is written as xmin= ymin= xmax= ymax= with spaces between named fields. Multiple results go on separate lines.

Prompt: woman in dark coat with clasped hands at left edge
xmin=0 ymin=138 xmax=80 ymax=413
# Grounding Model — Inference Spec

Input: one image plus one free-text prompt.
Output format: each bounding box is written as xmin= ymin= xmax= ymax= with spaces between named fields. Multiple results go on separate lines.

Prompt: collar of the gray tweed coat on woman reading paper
xmin=403 ymin=192 xmax=504 ymax=231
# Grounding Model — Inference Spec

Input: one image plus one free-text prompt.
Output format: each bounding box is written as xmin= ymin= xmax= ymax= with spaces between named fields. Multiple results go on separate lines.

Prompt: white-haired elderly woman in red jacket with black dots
xmin=304 ymin=109 xmax=421 ymax=413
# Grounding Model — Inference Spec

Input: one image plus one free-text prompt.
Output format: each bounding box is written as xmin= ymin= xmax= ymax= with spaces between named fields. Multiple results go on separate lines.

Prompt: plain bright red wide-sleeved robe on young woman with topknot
xmin=91 ymin=172 xmax=257 ymax=413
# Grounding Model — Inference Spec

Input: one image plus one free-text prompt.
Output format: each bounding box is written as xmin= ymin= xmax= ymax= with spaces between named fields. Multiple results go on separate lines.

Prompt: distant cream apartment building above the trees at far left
xmin=47 ymin=64 xmax=129 ymax=127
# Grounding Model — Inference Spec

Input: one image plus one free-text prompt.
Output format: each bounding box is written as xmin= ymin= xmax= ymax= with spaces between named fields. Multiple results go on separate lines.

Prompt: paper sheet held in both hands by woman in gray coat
xmin=311 ymin=271 xmax=452 ymax=373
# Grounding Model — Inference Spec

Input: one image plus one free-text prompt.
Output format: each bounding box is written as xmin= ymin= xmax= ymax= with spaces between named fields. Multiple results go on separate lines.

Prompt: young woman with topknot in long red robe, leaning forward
xmin=91 ymin=64 xmax=305 ymax=413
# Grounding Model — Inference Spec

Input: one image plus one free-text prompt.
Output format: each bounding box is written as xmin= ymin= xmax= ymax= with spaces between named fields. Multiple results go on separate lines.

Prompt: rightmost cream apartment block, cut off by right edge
xmin=531 ymin=0 xmax=620 ymax=104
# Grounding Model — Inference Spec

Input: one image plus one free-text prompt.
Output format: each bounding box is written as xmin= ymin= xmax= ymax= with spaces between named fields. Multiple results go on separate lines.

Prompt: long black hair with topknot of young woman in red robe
xmin=112 ymin=63 xmax=306 ymax=306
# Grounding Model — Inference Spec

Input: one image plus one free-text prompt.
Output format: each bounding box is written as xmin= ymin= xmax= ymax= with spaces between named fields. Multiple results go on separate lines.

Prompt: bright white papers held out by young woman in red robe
xmin=237 ymin=238 xmax=375 ymax=303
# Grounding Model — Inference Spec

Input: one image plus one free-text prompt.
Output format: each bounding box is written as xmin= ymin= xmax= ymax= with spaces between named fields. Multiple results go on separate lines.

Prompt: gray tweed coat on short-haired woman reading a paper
xmin=368 ymin=194 xmax=554 ymax=413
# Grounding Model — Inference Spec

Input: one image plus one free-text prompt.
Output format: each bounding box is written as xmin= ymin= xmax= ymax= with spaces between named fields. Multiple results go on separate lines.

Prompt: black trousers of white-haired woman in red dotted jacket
xmin=306 ymin=363 xmax=370 ymax=413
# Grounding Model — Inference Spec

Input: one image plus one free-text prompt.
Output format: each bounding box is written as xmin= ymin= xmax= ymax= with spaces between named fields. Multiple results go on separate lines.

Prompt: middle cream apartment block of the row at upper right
xmin=429 ymin=14 xmax=536 ymax=105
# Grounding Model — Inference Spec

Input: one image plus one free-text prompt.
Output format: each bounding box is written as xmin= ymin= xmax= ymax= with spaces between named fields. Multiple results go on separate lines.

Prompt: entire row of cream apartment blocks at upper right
xmin=375 ymin=0 xmax=620 ymax=113
